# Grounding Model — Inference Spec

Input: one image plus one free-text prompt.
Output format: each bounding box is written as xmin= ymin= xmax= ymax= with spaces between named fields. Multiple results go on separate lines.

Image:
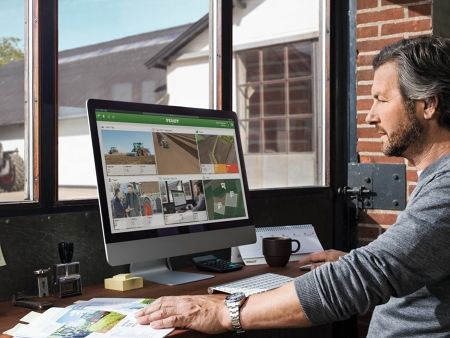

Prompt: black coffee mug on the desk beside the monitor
xmin=263 ymin=237 xmax=300 ymax=267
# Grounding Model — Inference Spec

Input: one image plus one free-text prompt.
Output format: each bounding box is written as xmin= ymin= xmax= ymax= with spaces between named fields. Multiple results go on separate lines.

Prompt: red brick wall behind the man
xmin=356 ymin=0 xmax=432 ymax=337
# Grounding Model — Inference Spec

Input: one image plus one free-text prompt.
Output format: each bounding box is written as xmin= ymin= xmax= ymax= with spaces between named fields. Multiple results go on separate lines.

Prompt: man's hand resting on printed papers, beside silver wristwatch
xmin=135 ymin=296 xmax=232 ymax=334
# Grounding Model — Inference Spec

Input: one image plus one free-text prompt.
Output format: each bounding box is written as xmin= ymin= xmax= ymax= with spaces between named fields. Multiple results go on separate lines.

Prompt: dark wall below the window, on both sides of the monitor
xmin=0 ymin=188 xmax=333 ymax=301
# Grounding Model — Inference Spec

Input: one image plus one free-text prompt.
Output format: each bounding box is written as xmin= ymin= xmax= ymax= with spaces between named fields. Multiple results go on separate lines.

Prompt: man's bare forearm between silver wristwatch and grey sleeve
xmin=240 ymin=282 xmax=311 ymax=330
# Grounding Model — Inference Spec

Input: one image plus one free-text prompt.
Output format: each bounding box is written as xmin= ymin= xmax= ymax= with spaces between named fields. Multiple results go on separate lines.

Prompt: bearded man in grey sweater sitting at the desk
xmin=136 ymin=37 xmax=450 ymax=338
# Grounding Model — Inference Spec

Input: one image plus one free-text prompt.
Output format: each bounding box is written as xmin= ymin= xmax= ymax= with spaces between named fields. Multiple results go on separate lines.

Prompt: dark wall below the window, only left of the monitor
xmin=0 ymin=211 xmax=128 ymax=301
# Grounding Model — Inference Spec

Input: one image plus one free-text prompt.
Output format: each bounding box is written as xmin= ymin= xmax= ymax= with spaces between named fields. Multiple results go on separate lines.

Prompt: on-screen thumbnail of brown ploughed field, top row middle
xmin=153 ymin=132 xmax=200 ymax=175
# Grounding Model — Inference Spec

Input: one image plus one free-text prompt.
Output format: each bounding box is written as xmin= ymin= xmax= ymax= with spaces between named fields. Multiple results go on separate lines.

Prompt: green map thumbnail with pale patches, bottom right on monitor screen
xmin=203 ymin=179 xmax=246 ymax=220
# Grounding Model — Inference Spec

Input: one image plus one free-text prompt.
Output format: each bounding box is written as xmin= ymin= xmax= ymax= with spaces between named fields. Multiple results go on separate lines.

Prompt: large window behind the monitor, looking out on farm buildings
xmin=0 ymin=0 xmax=325 ymax=214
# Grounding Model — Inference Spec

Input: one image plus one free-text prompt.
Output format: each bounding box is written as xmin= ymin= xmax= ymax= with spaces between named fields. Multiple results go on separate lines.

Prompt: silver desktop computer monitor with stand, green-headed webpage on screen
xmin=86 ymin=99 xmax=256 ymax=285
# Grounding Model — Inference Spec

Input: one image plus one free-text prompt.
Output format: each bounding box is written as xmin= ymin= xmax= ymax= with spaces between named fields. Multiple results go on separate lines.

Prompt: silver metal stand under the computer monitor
xmin=130 ymin=258 xmax=214 ymax=285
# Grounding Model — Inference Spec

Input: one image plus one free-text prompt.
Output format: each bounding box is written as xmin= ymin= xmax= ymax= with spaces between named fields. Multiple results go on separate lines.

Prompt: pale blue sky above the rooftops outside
xmin=0 ymin=0 xmax=209 ymax=51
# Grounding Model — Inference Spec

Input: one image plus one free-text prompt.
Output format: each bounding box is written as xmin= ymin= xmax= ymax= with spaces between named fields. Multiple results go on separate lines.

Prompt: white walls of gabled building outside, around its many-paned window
xmin=167 ymin=0 xmax=321 ymax=189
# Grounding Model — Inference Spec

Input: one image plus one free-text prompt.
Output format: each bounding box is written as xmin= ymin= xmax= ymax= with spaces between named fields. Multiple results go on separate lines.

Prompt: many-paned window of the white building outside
xmin=237 ymin=41 xmax=316 ymax=154
